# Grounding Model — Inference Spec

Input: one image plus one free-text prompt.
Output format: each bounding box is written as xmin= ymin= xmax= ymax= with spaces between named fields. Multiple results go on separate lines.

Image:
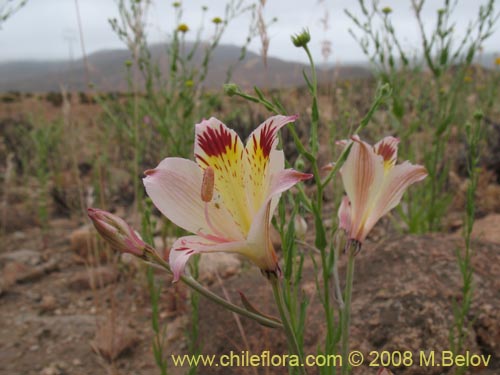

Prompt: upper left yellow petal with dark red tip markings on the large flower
xmin=194 ymin=117 xmax=251 ymax=233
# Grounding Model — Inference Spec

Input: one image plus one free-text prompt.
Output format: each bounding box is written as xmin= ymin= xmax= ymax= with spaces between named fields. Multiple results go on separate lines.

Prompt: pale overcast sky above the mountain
xmin=0 ymin=0 xmax=500 ymax=63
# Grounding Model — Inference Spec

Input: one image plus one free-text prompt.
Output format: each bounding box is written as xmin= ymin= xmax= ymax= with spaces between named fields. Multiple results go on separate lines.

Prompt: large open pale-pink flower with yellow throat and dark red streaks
xmin=144 ymin=116 xmax=312 ymax=281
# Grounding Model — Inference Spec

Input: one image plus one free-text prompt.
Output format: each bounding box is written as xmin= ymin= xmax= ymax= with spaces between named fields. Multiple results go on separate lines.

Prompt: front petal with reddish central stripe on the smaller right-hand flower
xmin=340 ymin=136 xmax=384 ymax=240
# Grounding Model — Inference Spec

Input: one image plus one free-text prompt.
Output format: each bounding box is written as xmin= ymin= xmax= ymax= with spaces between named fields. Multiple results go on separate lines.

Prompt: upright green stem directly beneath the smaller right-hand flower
xmin=340 ymin=244 xmax=358 ymax=375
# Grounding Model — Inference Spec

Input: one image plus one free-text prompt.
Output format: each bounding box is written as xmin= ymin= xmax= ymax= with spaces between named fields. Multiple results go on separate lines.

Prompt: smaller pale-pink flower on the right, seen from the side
xmin=338 ymin=135 xmax=427 ymax=243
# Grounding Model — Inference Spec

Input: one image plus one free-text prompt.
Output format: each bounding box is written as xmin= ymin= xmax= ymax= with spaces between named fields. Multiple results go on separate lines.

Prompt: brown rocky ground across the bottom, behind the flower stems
xmin=0 ymin=215 xmax=500 ymax=375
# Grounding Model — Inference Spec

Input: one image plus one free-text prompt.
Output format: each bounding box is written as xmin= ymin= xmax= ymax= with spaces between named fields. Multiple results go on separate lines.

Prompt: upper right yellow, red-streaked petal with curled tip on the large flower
xmin=245 ymin=115 xmax=298 ymax=214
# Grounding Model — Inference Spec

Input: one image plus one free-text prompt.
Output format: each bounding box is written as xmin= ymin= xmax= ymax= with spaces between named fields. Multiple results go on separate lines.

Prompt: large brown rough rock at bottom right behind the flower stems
xmin=194 ymin=233 xmax=500 ymax=375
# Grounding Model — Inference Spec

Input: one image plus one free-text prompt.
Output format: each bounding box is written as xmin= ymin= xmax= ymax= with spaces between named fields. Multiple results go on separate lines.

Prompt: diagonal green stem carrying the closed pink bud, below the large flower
xmin=145 ymin=248 xmax=283 ymax=328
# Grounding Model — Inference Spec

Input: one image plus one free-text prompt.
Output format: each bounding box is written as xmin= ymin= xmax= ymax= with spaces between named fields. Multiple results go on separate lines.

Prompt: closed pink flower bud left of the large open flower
xmin=87 ymin=208 xmax=147 ymax=256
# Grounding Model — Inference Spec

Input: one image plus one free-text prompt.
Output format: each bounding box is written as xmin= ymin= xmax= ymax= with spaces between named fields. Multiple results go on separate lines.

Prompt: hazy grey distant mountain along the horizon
xmin=0 ymin=44 xmax=371 ymax=92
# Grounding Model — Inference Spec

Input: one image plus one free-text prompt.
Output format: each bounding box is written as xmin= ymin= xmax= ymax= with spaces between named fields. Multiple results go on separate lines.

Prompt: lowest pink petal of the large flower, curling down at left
xmin=169 ymin=236 xmax=247 ymax=282
